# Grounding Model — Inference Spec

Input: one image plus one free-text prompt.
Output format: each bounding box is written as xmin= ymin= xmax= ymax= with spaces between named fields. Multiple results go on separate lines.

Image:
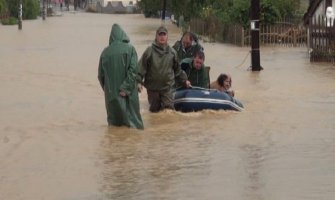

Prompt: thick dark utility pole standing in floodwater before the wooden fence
xmin=250 ymin=0 xmax=263 ymax=71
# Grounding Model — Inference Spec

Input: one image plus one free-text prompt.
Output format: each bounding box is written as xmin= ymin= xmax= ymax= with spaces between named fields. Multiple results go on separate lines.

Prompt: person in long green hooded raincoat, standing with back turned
xmin=98 ymin=24 xmax=144 ymax=129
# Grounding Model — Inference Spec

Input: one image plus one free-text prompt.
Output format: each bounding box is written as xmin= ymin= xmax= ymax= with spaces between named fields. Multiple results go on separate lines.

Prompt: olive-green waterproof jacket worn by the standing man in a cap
xmin=138 ymin=42 xmax=187 ymax=91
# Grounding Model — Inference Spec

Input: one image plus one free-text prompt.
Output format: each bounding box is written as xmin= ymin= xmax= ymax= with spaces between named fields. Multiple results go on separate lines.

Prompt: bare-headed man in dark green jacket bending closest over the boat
xmin=180 ymin=51 xmax=209 ymax=88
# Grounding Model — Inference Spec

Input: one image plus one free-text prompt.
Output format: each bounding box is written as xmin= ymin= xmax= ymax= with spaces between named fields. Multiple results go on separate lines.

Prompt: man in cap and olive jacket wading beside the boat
xmin=138 ymin=26 xmax=190 ymax=112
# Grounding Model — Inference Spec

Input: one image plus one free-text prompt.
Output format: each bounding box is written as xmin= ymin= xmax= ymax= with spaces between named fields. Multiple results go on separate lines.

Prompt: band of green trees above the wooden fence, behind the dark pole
xmin=139 ymin=0 xmax=299 ymax=27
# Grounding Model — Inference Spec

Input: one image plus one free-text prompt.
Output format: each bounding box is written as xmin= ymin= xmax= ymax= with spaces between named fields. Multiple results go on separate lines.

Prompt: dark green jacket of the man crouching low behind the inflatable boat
xmin=180 ymin=58 xmax=209 ymax=88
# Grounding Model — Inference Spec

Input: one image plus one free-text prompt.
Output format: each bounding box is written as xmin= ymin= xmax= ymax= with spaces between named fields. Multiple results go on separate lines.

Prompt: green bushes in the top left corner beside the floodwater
xmin=7 ymin=0 xmax=40 ymax=19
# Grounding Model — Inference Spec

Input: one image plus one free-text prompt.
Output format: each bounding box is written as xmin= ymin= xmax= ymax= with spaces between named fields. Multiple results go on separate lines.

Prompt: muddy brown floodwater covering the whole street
xmin=0 ymin=12 xmax=335 ymax=200
